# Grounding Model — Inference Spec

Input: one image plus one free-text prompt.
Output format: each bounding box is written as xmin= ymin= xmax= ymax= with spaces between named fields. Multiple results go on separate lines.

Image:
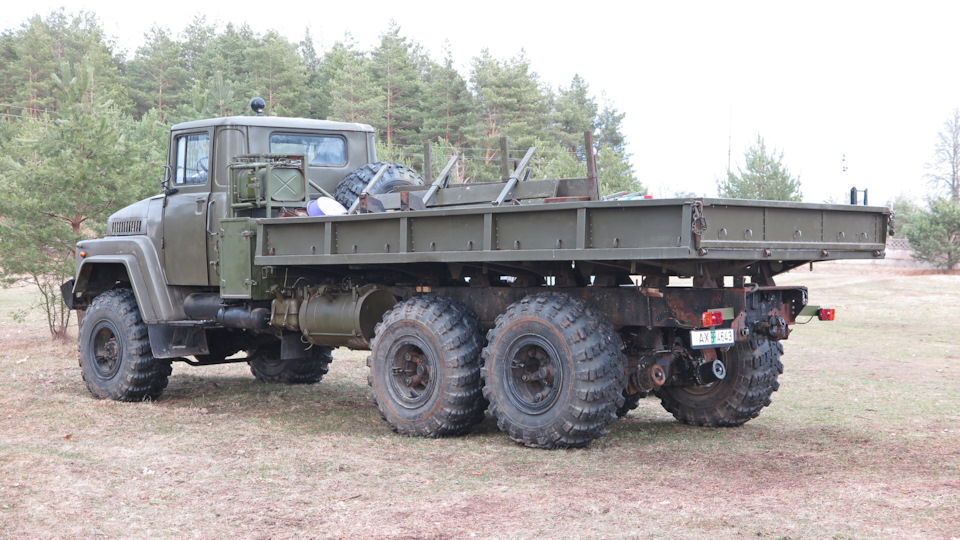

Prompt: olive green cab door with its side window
xmin=162 ymin=130 xmax=213 ymax=285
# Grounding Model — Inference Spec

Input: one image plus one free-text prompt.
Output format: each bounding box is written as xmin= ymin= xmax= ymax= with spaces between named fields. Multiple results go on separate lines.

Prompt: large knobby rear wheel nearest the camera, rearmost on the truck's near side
xmin=481 ymin=293 xmax=626 ymax=449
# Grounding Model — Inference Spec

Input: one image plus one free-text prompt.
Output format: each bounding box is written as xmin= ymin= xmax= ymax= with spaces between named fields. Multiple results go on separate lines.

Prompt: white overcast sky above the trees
xmin=7 ymin=0 xmax=960 ymax=204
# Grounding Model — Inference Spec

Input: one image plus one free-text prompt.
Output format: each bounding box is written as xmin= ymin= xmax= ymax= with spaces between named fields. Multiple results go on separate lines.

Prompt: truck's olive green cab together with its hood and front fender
xmin=62 ymin=109 xmax=384 ymax=359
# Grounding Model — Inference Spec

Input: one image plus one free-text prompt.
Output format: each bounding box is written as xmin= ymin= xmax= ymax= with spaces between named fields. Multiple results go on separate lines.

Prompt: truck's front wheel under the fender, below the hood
xmin=78 ymin=289 xmax=172 ymax=401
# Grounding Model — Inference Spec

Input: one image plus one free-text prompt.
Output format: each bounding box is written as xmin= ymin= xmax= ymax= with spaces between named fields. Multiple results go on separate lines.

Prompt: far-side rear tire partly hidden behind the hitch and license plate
xmin=657 ymin=339 xmax=783 ymax=427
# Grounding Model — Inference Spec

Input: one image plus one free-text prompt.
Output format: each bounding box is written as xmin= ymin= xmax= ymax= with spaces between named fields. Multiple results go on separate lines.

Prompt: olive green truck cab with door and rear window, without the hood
xmin=159 ymin=116 xmax=376 ymax=286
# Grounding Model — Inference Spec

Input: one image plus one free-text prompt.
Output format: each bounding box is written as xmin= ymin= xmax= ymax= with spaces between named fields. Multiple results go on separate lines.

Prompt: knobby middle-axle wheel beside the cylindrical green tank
xmin=367 ymin=295 xmax=487 ymax=437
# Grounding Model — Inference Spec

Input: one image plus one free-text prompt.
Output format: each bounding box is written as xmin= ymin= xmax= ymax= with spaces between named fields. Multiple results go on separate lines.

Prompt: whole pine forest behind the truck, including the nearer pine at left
xmin=0 ymin=10 xmax=642 ymax=339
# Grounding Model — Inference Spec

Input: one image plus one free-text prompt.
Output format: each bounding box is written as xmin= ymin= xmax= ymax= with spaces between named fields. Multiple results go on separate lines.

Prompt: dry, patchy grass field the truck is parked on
xmin=0 ymin=266 xmax=960 ymax=540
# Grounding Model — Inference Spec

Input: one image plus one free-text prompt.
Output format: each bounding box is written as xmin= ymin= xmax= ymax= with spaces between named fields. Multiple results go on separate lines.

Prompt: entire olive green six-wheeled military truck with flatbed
xmin=63 ymin=99 xmax=891 ymax=448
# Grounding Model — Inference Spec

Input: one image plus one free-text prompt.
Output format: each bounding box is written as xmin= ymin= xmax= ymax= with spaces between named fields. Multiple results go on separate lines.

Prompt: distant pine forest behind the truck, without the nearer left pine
xmin=0 ymin=10 xmax=642 ymax=193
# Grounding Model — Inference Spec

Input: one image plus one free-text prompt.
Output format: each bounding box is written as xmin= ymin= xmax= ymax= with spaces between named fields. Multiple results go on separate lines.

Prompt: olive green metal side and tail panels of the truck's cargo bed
xmin=249 ymin=195 xmax=890 ymax=274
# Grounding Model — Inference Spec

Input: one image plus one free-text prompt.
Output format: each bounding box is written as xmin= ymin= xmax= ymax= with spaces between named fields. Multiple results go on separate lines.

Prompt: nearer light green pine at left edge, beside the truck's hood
xmin=0 ymin=61 xmax=152 ymax=339
